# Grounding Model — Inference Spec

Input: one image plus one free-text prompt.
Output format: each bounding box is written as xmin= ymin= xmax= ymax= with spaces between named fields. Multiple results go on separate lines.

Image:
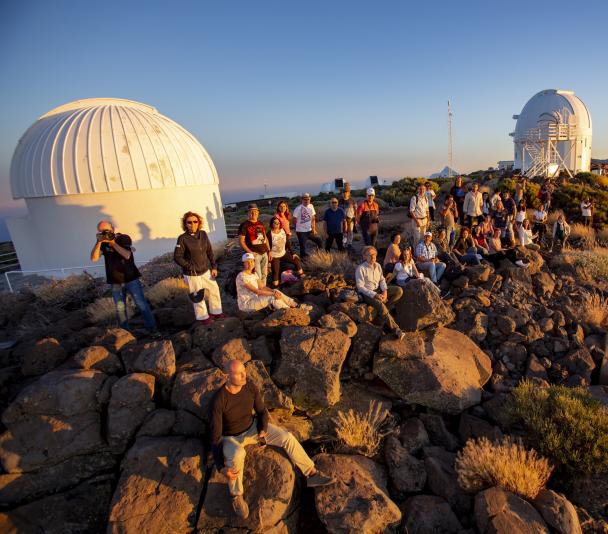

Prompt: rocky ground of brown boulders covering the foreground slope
xmin=0 ymin=227 xmax=608 ymax=534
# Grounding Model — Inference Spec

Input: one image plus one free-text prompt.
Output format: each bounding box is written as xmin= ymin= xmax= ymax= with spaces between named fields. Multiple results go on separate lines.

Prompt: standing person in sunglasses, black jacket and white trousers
xmin=173 ymin=211 xmax=225 ymax=325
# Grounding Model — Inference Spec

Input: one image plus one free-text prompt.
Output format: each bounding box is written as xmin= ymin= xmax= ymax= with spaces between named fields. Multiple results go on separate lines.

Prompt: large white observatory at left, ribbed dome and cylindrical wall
xmin=8 ymin=98 xmax=226 ymax=274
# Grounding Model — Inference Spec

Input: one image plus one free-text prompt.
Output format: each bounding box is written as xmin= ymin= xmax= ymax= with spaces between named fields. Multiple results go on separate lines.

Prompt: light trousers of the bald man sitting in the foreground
xmin=222 ymin=420 xmax=315 ymax=495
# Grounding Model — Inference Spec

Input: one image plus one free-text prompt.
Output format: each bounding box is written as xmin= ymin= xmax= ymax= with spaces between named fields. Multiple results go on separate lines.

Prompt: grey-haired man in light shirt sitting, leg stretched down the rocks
xmin=355 ymin=246 xmax=405 ymax=339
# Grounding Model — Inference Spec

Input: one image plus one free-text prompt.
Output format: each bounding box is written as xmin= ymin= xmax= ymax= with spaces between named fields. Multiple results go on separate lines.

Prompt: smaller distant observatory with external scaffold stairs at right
xmin=509 ymin=89 xmax=591 ymax=176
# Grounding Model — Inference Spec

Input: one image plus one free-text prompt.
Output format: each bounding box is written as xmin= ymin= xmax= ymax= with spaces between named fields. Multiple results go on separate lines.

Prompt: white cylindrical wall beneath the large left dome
xmin=7 ymin=184 xmax=226 ymax=276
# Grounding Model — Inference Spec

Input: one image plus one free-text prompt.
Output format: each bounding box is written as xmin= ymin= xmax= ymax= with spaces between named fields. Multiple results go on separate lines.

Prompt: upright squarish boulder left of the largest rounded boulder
xmin=273 ymin=326 xmax=350 ymax=410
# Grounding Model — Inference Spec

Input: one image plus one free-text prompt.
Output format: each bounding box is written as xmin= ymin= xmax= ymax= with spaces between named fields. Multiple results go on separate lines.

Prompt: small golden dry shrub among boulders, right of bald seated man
xmin=333 ymin=401 xmax=391 ymax=457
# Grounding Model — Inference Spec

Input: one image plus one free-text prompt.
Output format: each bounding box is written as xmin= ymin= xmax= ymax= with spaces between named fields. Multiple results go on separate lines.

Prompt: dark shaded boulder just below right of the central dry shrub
xmin=384 ymin=436 xmax=426 ymax=499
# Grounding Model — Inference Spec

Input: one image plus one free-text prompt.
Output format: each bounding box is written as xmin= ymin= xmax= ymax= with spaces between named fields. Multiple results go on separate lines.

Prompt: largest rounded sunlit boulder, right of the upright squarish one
xmin=373 ymin=328 xmax=492 ymax=413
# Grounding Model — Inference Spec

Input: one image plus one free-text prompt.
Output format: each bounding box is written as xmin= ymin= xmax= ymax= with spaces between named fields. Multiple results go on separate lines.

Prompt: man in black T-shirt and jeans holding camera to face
xmin=91 ymin=221 xmax=158 ymax=336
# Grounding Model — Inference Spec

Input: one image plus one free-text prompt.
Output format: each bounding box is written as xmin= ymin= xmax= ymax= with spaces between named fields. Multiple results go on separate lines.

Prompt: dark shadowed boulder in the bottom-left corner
xmin=0 ymin=480 xmax=112 ymax=534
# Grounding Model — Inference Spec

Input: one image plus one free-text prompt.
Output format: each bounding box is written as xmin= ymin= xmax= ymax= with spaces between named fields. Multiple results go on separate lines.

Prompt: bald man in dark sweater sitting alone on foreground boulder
xmin=210 ymin=360 xmax=335 ymax=519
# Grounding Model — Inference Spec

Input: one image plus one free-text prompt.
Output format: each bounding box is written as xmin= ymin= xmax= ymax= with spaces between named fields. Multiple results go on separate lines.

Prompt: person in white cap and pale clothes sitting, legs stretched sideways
xmin=236 ymin=252 xmax=312 ymax=312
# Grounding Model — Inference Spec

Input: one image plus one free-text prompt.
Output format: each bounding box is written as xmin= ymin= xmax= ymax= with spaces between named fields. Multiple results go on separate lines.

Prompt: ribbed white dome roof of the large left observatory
xmin=11 ymin=98 xmax=218 ymax=198
